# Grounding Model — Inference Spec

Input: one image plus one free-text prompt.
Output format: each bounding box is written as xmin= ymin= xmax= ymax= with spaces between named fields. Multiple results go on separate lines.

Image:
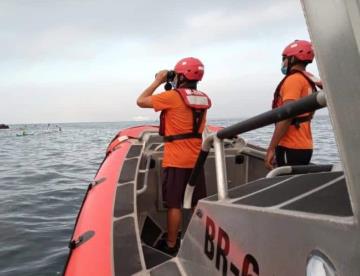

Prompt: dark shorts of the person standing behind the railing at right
xmin=275 ymin=146 xmax=312 ymax=166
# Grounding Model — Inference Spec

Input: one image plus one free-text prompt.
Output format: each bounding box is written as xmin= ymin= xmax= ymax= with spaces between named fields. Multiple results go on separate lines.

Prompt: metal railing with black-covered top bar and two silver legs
xmin=184 ymin=91 xmax=326 ymax=209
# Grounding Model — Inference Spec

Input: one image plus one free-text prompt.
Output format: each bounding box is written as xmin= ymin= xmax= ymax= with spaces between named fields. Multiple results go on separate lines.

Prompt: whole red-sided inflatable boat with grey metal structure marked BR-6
xmin=64 ymin=0 xmax=360 ymax=276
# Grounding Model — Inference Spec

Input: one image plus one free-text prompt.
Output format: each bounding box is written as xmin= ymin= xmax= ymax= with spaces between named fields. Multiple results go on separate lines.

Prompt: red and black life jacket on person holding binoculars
xmin=159 ymin=88 xmax=211 ymax=142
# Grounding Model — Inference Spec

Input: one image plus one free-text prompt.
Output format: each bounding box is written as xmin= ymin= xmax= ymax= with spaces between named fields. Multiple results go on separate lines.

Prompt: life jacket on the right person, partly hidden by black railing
xmin=272 ymin=69 xmax=323 ymax=128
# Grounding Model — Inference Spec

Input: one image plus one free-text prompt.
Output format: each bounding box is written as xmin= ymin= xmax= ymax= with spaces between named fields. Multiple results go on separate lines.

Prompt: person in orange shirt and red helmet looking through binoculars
xmin=137 ymin=57 xmax=211 ymax=255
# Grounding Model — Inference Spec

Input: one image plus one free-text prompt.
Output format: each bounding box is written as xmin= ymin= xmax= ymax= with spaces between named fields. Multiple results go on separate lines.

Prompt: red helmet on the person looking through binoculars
xmin=174 ymin=57 xmax=204 ymax=81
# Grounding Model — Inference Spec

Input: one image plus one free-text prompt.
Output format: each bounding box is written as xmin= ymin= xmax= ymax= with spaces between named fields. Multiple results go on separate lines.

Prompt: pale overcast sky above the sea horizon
xmin=0 ymin=0 xmax=317 ymax=124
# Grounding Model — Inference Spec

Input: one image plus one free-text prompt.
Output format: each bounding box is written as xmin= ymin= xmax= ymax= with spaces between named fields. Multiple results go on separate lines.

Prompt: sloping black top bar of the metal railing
xmin=216 ymin=92 xmax=324 ymax=139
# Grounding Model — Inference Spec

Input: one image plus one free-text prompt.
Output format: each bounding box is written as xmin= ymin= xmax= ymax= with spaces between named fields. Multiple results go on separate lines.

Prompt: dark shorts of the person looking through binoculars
xmin=162 ymin=167 xmax=206 ymax=209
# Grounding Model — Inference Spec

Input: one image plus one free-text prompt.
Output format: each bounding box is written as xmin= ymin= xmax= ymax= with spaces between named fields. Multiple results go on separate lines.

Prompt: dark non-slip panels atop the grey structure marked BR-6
xmin=217 ymin=172 xmax=353 ymax=217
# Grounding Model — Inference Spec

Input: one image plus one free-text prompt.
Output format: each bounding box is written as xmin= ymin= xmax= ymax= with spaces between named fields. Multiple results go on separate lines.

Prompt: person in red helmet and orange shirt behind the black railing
xmin=265 ymin=40 xmax=322 ymax=169
